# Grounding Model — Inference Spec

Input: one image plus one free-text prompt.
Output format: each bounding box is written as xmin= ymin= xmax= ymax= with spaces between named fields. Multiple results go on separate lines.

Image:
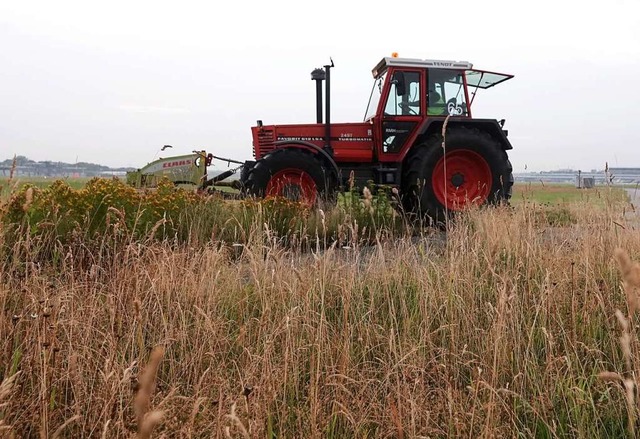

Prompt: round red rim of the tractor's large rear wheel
xmin=431 ymin=149 xmax=493 ymax=210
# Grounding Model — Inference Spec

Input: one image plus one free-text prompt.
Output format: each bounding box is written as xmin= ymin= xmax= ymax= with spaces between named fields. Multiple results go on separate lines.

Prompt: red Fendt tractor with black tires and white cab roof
xmin=240 ymin=56 xmax=513 ymax=220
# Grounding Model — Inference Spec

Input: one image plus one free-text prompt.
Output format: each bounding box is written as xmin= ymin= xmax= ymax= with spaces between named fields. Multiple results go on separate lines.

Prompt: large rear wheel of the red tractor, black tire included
xmin=401 ymin=127 xmax=513 ymax=223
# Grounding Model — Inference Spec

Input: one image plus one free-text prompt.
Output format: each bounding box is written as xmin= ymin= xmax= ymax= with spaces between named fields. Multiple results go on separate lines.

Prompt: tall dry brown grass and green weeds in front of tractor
xmin=0 ymin=177 xmax=640 ymax=438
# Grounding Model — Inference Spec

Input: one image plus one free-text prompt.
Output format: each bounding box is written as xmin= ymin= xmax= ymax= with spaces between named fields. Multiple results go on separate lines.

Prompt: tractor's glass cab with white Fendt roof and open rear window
xmin=364 ymin=56 xmax=513 ymax=162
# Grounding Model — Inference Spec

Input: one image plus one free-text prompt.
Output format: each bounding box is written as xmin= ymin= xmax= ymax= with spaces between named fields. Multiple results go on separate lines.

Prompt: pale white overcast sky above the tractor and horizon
xmin=0 ymin=0 xmax=640 ymax=171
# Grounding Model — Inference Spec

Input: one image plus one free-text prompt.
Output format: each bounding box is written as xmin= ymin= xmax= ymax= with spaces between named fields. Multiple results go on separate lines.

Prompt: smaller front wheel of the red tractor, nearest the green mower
xmin=245 ymin=148 xmax=336 ymax=204
